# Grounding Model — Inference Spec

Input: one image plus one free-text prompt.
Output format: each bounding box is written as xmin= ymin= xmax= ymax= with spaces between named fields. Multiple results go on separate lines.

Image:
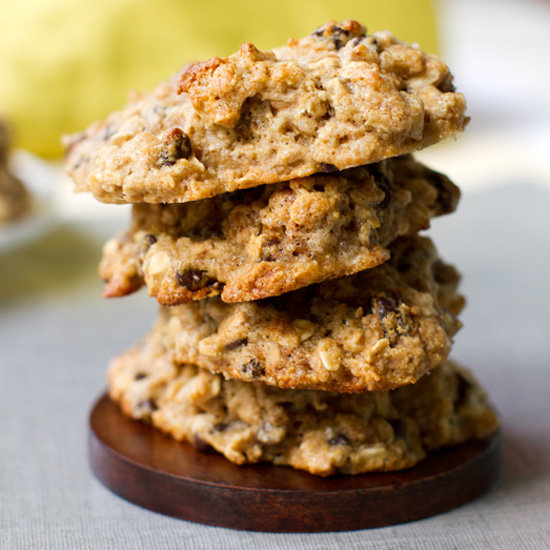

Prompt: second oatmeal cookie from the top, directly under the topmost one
xmin=99 ymin=156 xmax=459 ymax=305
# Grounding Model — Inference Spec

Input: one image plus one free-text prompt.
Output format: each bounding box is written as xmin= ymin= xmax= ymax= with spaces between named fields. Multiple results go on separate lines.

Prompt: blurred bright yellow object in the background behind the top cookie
xmin=0 ymin=0 xmax=436 ymax=157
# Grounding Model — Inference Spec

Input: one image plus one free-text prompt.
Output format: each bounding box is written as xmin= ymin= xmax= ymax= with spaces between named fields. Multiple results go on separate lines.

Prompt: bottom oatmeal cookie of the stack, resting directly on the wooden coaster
xmin=109 ymin=334 xmax=498 ymax=476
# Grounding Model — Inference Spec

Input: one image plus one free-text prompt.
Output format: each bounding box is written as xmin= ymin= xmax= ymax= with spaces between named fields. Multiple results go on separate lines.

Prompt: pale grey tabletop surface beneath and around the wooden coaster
xmin=0 ymin=180 xmax=550 ymax=550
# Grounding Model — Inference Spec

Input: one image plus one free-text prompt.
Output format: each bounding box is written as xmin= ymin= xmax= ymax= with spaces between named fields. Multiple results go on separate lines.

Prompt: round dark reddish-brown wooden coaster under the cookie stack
xmin=89 ymin=396 xmax=500 ymax=533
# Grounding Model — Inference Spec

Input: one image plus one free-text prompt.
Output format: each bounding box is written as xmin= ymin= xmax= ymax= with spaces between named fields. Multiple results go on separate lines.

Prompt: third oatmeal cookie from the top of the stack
xmin=148 ymin=237 xmax=463 ymax=392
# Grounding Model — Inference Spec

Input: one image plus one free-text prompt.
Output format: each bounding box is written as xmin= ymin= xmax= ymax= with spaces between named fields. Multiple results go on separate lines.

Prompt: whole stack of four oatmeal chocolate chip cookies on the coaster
xmin=66 ymin=21 xmax=497 ymax=476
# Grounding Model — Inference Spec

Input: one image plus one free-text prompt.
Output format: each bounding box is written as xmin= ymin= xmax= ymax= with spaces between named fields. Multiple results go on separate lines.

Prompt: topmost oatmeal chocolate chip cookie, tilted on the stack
xmin=65 ymin=21 xmax=467 ymax=203
